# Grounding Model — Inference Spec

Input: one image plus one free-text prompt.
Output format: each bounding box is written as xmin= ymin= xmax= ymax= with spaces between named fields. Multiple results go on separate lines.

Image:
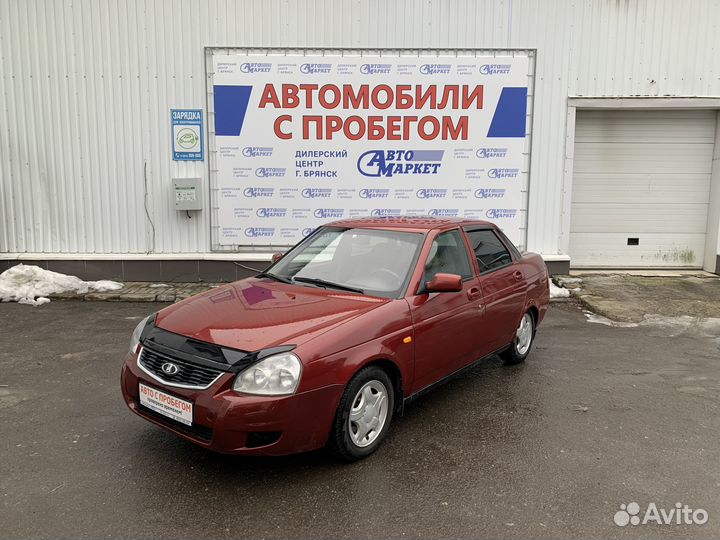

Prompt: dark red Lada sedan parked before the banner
xmin=122 ymin=217 xmax=549 ymax=461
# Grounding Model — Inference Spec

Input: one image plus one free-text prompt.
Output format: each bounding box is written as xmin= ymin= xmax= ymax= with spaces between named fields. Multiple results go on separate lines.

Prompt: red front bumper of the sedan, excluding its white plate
xmin=121 ymin=354 xmax=343 ymax=455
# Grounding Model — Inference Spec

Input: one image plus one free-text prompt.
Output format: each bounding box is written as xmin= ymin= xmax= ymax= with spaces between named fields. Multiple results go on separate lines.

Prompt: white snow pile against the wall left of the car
xmin=0 ymin=264 xmax=122 ymax=306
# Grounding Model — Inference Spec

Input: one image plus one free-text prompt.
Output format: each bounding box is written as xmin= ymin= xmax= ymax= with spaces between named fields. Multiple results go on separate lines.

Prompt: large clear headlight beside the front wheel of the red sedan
xmin=233 ymin=353 xmax=302 ymax=396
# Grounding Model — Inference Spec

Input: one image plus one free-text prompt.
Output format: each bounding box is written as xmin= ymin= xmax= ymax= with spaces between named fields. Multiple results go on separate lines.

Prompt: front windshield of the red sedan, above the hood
xmin=268 ymin=227 xmax=423 ymax=298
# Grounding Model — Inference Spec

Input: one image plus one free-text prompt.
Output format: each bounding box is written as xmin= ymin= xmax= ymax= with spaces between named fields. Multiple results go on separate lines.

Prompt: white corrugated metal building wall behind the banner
xmin=0 ymin=0 xmax=720 ymax=254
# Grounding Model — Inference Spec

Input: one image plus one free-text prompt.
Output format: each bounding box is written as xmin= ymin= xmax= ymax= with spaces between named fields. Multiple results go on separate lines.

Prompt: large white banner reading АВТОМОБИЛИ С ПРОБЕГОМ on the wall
xmin=212 ymin=54 xmax=529 ymax=246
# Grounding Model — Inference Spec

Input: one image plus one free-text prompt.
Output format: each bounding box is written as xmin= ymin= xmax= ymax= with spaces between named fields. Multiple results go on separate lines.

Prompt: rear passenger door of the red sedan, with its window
xmin=465 ymin=226 xmax=527 ymax=355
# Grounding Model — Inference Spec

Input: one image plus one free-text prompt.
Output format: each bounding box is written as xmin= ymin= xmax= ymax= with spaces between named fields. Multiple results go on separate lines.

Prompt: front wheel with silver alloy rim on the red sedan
xmin=329 ymin=366 xmax=395 ymax=462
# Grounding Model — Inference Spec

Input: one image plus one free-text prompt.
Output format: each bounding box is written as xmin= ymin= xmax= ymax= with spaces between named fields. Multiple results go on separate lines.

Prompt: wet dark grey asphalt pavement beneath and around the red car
xmin=0 ymin=301 xmax=720 ymax=538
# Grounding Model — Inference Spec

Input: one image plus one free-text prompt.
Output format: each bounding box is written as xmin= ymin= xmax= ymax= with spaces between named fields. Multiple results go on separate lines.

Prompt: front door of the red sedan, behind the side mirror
xmin=409 ymin=229 xmax=482 ymax=391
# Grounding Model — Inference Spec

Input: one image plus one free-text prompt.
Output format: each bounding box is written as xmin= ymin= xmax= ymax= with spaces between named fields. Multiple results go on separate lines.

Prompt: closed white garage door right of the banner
xmin=570 ymin=111 xmax=715 ymax=268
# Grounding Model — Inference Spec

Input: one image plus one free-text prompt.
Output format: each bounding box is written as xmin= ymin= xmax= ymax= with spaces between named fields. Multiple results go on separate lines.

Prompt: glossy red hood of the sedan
xmin=155 ymin=278 xmax=390 ymax=351
